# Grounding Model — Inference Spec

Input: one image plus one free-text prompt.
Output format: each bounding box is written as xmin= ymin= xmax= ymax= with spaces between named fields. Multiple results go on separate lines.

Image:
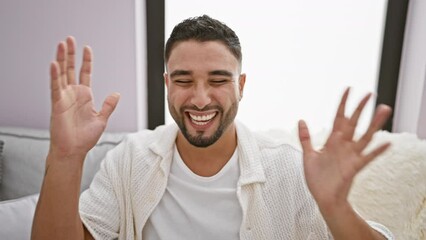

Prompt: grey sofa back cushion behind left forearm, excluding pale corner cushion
xmin=0 ymin=127 xmax=124 ymax=200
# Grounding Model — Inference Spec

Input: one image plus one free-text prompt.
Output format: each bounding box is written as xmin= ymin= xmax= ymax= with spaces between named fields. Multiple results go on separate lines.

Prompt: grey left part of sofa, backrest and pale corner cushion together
xmin=0 ymin=127 xmax=125 ymax=240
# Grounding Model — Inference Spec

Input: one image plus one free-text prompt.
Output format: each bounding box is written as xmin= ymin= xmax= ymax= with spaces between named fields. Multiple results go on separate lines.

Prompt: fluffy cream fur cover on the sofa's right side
xmin=266 ymin=130 xmax=426 ymax=240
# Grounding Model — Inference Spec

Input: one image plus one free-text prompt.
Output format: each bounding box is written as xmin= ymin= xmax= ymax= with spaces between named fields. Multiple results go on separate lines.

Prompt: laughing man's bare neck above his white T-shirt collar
xmin=176 ymin=123 xmax=237 ymax=177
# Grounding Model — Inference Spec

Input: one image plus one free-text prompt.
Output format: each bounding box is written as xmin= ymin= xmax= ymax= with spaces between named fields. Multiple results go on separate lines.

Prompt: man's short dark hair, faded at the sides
xmin=164 ymin=15 xmax=242 ymax=65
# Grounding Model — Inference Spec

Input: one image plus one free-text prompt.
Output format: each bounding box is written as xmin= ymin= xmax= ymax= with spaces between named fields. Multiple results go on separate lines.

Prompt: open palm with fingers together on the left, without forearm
xmin=50 ymin=37 xmax=120 ymax=157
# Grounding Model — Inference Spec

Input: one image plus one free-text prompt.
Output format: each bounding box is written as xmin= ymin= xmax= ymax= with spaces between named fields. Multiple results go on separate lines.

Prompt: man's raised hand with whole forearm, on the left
xmin=31 ymin=37 xmax=120 ymax=240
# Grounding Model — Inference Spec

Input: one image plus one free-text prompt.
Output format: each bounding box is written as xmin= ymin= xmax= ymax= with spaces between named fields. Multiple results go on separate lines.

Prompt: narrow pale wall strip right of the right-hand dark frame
xmin=393 ymin=0 xmax=426 ymax=138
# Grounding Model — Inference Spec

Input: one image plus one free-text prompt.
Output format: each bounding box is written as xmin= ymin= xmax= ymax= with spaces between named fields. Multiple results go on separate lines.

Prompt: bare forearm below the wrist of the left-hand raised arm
xmin=31 ymin=154 xmax=84 ymax=239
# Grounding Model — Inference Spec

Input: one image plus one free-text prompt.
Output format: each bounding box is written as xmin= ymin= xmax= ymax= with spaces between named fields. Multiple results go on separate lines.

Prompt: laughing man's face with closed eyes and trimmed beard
xmin=164 ymin=40 xmax=245 ymax=147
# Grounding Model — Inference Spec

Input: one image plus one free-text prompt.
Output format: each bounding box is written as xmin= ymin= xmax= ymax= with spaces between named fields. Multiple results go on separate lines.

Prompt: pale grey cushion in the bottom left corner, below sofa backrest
xmin=0 ymin=194 xmax=38 ymax=240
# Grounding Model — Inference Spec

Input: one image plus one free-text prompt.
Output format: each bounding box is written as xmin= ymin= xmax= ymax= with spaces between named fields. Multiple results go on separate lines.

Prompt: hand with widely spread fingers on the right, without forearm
xmin=299 ymin=89 xmax=391 ymax=212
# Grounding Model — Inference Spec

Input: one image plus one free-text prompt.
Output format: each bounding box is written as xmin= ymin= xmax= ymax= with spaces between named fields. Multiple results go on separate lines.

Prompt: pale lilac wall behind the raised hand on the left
xmin=0 ymin=0 xmax=146 ymax=131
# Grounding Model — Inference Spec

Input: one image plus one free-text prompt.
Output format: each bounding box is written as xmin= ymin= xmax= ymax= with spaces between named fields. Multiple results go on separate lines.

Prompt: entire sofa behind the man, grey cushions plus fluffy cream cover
xmin=0 ymin=127 xmax=426 ymax=240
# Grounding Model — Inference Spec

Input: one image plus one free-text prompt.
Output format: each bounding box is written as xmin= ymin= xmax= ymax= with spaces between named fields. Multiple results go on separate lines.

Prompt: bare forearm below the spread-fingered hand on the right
xmin=320 ymin=203 xmax=386 ymax=240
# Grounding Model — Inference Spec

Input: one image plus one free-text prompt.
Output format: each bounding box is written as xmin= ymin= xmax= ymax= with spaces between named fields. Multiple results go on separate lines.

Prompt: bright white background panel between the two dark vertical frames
xmin=166 ymin=0 xmax=387 ymax=132
